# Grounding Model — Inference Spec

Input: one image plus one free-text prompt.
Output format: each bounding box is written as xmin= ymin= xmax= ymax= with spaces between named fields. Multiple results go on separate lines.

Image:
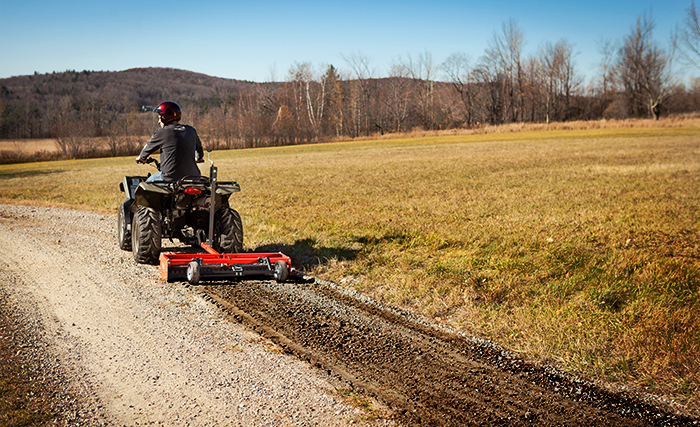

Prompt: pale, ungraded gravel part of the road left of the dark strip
xmin=0 ymin=205 xmax=393 ymax=426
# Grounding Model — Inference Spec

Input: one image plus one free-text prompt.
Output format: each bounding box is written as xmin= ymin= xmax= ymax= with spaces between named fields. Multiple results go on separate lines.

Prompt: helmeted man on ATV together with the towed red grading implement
xmin=117 ymin=101 xmax=308 ymax=284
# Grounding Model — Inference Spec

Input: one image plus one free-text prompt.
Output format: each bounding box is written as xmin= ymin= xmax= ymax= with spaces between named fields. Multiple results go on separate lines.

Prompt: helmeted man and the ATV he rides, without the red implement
xmin=117 ymin=101 xmax=243 ymax=264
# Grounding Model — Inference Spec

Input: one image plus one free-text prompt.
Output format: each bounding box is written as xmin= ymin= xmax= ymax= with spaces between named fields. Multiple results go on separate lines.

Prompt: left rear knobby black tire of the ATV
xmin=131 ymin=208 xmax=162 ymax=264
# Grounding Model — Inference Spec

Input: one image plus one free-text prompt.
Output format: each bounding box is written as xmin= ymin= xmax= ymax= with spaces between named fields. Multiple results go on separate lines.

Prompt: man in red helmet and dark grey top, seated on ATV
xmin=136 ymin=101 xmax=204 ymax=182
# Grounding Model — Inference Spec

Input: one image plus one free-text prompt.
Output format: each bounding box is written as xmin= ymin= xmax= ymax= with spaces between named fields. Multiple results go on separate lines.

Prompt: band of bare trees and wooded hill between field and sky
xmin=0 ymin=8 xmax=700 ymax=157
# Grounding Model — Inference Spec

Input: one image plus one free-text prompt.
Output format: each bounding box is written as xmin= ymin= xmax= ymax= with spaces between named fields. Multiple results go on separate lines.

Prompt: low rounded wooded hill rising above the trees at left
xmin=0 ymin=68 xmax=249 ymax=112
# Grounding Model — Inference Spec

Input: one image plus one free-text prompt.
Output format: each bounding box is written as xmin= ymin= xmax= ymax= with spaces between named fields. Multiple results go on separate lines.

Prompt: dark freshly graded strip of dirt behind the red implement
xmin=198 ymin=281 xmax=696 ymax=426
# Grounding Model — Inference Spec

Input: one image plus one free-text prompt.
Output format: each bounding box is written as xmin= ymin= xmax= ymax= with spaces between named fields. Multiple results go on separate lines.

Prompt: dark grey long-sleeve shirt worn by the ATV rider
xmin=139 ymin=123 xmax=204 ymax=182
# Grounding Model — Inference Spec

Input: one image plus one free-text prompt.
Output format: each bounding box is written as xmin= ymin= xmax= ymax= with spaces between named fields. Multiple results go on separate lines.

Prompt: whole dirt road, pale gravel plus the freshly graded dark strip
xmin=0 ymin=206 xmax=697 ymax=426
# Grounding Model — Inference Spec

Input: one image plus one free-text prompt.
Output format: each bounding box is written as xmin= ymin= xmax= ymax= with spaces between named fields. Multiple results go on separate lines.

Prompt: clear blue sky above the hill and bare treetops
xmin=0 ymin=0 xmax=691 ymax=83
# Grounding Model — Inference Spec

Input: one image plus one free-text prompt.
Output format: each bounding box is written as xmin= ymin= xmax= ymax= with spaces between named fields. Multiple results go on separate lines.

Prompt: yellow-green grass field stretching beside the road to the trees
xmin=0 ymin=126 xmax=700 ymax=408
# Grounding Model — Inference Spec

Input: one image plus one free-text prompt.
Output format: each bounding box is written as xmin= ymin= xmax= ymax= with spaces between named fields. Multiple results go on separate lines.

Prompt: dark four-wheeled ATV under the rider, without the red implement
xmin=117 ymin=157 xmax=243 ymax=264
